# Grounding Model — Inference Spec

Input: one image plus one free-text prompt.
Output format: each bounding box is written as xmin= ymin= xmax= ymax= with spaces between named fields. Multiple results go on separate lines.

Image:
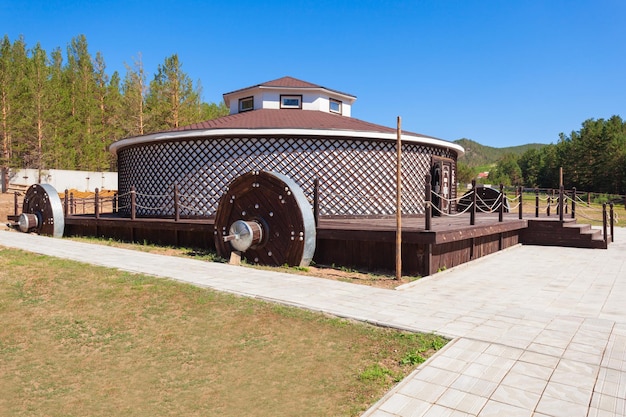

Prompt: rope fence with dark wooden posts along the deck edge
xmin=48 ymin=174 xmax=626 ymax=244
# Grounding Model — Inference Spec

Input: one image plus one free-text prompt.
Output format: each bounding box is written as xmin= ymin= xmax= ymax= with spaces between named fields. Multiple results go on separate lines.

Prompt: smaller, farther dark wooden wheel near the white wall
xmin=18 ymin=184 xmax=65 ymax=237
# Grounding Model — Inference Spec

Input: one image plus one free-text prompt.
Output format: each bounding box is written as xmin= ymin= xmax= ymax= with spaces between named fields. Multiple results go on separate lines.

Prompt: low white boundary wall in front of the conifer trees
xmin=9 ymin=169 xmax=117 ymax=193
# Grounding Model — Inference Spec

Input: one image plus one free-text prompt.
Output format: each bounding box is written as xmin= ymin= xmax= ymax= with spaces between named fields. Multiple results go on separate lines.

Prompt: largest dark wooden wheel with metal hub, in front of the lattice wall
xmin=215 ymin=171 xmax=316 ymax=266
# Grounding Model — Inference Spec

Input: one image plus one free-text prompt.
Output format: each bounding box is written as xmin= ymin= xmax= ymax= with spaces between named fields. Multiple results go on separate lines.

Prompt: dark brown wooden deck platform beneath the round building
xmin=65 ymin=214 xmax=527 ymax=276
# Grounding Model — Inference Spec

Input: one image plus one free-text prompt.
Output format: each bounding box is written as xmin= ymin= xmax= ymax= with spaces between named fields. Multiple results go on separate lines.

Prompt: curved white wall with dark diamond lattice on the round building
xmin=118 ymin=137 xmax=456 ymax=217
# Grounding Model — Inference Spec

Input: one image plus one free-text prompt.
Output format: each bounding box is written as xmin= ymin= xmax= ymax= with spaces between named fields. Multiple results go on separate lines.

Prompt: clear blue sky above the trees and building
xmin=0 ymin=0 xmax=626 ymax=147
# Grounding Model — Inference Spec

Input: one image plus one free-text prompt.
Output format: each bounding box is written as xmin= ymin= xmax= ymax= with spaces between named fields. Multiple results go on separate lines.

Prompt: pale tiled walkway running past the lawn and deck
xmin=0 ymin=229 xmax=626 ymax=417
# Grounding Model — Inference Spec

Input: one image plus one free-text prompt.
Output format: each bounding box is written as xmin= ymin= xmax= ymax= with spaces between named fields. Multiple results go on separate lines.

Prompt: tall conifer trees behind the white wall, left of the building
xmin=0 ymin=35 xmax=228 ymax=171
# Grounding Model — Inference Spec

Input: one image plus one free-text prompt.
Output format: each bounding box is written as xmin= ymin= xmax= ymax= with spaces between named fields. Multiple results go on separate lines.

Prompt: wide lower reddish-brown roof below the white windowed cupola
xmin=168 ymin=109 xmax=436 ymax=139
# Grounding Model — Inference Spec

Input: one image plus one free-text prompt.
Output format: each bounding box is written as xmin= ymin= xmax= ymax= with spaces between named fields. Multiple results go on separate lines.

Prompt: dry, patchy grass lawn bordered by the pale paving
xmin=0 ymin=248 xmax=446 ymax=417
